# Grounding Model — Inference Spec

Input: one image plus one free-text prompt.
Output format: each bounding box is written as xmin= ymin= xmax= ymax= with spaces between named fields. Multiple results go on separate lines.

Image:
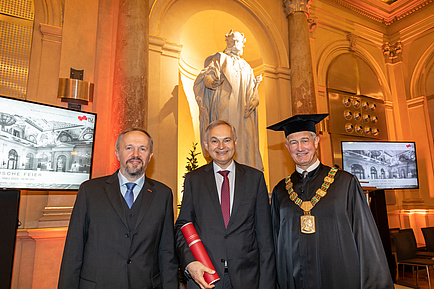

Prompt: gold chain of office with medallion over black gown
xmin=285 ymin=167 xmax=338 ymax=234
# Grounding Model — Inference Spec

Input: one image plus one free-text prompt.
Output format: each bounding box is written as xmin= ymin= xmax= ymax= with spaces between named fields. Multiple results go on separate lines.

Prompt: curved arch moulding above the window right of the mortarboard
xmin=316 ymin=40 xmax=391 ymax=100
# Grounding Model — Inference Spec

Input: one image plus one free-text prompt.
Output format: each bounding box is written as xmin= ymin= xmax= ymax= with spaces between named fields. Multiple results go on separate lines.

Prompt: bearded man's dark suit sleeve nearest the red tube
xmin=158 ymin=189 xmax=178 ymax=289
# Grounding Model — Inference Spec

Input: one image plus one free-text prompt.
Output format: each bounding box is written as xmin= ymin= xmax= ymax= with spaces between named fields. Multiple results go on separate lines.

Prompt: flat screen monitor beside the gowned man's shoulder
xmin=341 ymin=141 xmax=419 ymax=190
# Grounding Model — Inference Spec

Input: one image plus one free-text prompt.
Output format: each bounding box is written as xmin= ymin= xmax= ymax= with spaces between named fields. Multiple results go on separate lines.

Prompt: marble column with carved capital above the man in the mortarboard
xmin=284 ymin=0 xmax=316 ymax=114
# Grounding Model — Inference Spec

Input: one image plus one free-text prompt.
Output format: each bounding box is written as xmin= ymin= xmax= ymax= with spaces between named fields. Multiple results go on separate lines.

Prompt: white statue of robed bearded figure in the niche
xmin=194 ymin=30 xmax=264 ymax=170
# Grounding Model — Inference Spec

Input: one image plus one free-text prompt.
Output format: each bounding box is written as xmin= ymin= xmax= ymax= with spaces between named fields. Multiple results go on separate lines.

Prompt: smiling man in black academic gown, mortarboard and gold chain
xmin=268 ymin=114 xmax=393 ymax=289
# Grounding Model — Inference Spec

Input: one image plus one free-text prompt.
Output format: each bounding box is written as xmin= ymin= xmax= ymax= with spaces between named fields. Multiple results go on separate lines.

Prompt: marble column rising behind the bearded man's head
xmin=111 ymin=0 xmax=149 ymax=148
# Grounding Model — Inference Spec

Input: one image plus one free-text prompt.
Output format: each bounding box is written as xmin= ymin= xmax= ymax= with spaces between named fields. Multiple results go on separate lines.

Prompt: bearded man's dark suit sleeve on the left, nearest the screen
xmin=58 ymin=186 xmax=89 ymax=289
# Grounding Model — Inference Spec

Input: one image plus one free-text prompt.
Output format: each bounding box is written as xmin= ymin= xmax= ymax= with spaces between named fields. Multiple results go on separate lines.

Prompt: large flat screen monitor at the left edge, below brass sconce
xmin=0 ymin=96 xmax=96 ymax=190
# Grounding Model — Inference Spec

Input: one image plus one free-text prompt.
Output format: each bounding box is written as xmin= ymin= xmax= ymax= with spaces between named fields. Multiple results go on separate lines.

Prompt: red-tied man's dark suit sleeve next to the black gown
xmin=255 ymin=173 xmax=276 ymax=289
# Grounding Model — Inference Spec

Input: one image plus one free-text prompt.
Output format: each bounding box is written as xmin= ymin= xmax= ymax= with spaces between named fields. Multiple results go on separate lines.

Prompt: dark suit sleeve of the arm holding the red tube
xmin=175 ymin=174 xmax=196 ymax=268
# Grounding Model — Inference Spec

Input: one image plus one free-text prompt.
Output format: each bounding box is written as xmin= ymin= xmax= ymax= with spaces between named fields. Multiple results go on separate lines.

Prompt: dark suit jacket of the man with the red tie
xmin=175 ymin=163 xmax=276 ymax=289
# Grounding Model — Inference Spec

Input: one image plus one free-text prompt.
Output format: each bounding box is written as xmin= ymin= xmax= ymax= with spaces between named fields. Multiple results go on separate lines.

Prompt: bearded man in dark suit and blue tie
xmin=58 ymin=129 xmax=178 ymax=289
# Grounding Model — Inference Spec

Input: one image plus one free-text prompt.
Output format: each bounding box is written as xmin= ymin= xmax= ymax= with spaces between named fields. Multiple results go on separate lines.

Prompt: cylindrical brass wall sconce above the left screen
xmin=57 ymin=68 xmax=94 ymax=110
